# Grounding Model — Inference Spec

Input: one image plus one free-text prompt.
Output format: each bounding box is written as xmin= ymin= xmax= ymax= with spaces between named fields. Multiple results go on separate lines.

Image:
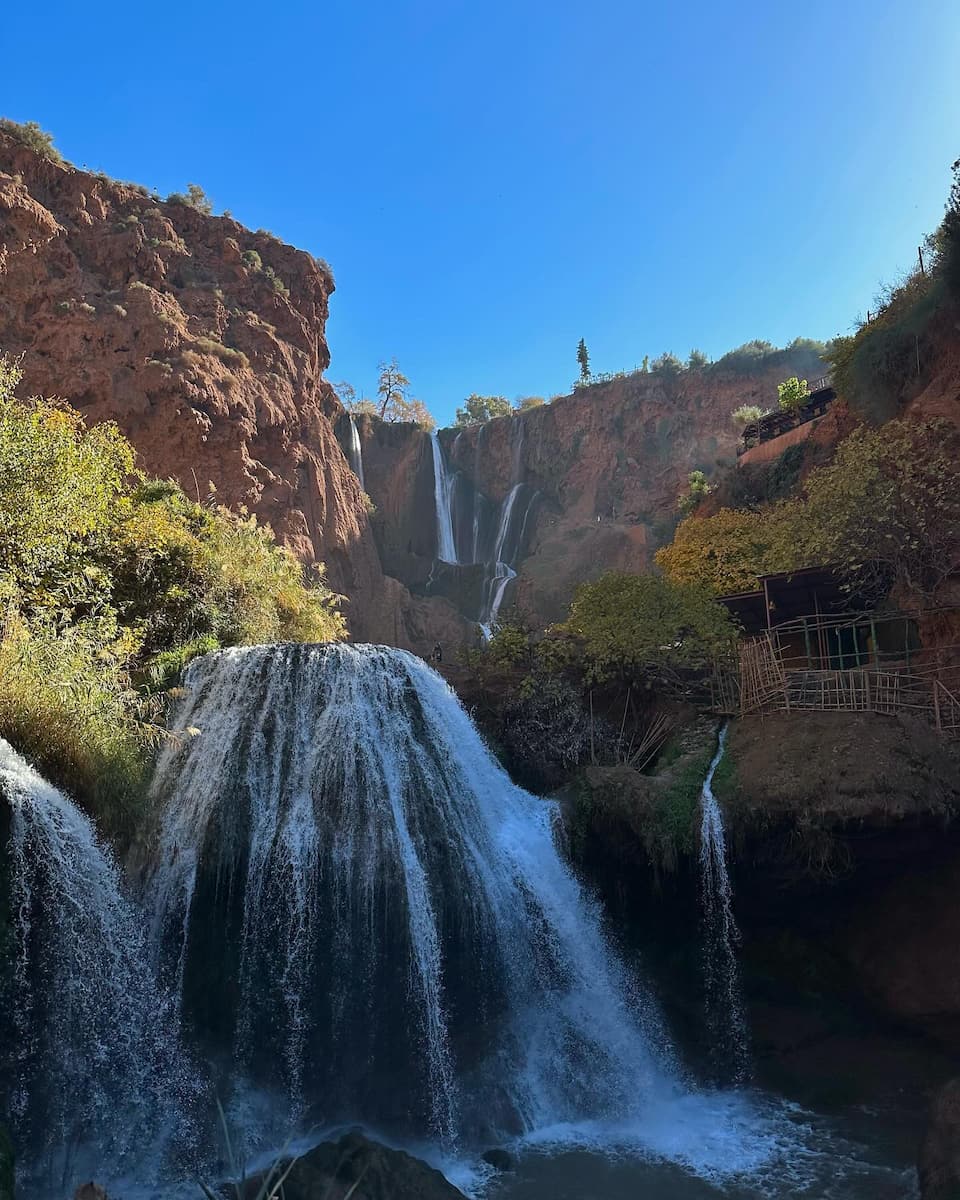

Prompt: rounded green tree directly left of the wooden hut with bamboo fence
xmin=558 ymin=571 xmax=736 ymax=683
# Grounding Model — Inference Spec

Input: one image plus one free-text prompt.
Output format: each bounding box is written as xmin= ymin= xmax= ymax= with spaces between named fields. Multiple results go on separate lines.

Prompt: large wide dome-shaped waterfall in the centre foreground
xmin=146 ymin=644 xmax=682 ymax=1146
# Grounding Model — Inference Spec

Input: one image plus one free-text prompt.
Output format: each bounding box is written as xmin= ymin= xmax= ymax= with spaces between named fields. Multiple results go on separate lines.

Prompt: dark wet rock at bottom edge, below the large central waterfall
xmin=244 ymin=1132 xmax=463 ymax=1200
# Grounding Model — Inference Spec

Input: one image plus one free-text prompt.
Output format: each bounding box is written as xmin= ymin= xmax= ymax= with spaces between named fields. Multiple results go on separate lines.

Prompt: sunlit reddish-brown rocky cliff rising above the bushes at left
xmin=0 ymin=133 xmax=468 ymax=649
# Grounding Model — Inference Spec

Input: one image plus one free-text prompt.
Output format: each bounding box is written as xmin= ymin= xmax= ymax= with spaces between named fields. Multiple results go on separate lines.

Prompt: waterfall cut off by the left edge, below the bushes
xmin=0 ymin=739 xmax=197 ymax=1195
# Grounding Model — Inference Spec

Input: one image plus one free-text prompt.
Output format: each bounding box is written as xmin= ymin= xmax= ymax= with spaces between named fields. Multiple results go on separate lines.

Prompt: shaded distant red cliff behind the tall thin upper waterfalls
xmin=359 ymin=350 xmax=822 ymax=625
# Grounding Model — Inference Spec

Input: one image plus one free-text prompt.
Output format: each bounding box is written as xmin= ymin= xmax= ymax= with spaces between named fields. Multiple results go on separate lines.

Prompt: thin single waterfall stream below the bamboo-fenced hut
xmin=700 ymin=725 xmax=749 ymax=1084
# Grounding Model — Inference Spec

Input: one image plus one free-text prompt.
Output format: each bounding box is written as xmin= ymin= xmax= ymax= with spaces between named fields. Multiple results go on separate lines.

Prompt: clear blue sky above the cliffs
xmin=0 ymin=0 xmax=960 ymax=424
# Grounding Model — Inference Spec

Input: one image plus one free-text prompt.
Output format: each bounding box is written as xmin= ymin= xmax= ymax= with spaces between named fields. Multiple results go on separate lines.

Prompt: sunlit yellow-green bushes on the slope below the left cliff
xmin=0 ymin=358 xmax=346 ymax=832
